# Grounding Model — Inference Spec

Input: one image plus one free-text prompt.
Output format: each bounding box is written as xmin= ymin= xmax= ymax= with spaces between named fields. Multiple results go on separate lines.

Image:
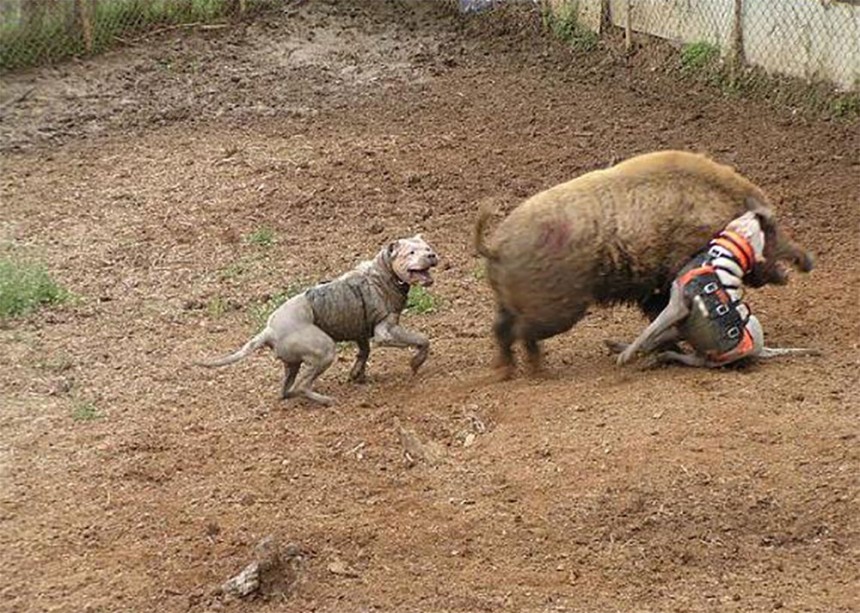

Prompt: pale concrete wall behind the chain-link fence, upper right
xmin=551 ymin=0 xmax=860 ymax=91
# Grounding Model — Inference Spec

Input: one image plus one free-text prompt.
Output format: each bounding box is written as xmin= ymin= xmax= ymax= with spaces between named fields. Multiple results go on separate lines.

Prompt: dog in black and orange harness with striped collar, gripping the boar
xmin=606 ymin=212 xmax=820 ymax=368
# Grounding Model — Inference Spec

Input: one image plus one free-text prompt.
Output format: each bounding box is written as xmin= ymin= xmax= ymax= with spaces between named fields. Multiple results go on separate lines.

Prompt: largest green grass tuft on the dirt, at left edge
xmin=0 ymin=259 xmax=69 ymax=318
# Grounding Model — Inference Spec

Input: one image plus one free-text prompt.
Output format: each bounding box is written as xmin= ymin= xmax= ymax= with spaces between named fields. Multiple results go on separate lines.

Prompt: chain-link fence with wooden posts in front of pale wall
xmin=540 ymin=0 xmax=860 ymax=116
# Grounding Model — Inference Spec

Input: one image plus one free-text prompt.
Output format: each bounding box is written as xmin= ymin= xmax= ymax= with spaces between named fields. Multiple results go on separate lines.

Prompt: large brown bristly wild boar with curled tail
xmin=474 ymin=151 xmax=813 ymax=377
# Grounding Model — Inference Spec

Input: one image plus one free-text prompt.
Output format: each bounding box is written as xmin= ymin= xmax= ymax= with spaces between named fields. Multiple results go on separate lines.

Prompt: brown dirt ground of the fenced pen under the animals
xmin=0 ymin=0 xmax=860 ymax=613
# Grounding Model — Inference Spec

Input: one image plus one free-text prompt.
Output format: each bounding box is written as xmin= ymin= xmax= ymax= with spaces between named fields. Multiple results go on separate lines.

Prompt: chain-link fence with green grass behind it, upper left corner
xmin=0 ymin=0 xmax=277 ymax=70
